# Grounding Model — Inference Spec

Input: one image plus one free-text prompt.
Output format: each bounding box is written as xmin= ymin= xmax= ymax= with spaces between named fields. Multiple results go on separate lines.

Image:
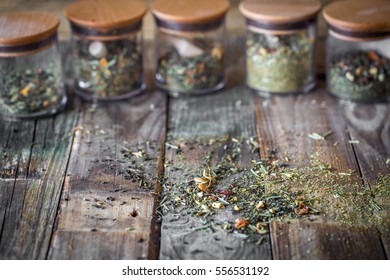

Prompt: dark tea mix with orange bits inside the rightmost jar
xmin=328 ymin=50 xmax=390 ymax=101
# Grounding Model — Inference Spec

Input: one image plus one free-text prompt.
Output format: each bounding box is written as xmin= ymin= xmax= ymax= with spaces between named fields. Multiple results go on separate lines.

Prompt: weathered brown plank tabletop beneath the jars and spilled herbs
xmin=0 ymin=33 xmax=390 ymax=259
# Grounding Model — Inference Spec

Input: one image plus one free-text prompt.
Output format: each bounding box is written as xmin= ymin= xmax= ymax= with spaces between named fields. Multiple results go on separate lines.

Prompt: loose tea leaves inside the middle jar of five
xmin=156 ymin=38 xmax=223 ymax=92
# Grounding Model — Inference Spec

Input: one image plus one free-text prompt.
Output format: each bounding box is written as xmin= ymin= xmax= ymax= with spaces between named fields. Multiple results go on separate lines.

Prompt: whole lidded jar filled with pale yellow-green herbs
xmin=239 ymin=0 xmax=321 ymax=94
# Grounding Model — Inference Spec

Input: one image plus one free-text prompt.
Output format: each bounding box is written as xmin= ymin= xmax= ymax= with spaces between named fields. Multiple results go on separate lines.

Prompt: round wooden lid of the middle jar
xmin=151 ymin=0 xmax=229 ymax=23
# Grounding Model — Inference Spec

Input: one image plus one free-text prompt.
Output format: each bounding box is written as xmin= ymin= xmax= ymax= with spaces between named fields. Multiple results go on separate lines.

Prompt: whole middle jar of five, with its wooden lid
xmin=151 ymin=0 xmax=229 ymax=96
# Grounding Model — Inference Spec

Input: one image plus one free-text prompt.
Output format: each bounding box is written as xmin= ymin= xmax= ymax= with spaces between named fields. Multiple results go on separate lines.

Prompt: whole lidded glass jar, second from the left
xmin=65 ymin=0 xmax=146 ymax=101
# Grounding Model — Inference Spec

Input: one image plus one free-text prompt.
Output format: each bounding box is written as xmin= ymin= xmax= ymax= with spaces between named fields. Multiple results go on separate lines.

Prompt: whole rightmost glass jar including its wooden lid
xmin=323 ymin=0 xmax=390 ymax=102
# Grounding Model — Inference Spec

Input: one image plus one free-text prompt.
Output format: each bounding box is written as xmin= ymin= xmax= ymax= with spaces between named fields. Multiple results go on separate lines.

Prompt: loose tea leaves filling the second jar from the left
xmin=74 ymin=39 xmax=143 ymax=98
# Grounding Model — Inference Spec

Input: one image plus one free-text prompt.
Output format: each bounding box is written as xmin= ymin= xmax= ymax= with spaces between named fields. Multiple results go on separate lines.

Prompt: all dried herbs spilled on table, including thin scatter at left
xmin=77 ymin=130 xmax=390 ymax=243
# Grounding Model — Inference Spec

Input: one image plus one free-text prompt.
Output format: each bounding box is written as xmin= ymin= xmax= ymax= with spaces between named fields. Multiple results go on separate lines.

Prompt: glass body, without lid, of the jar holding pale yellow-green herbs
xmin=246 ymin=22 xmax=316 ymax=94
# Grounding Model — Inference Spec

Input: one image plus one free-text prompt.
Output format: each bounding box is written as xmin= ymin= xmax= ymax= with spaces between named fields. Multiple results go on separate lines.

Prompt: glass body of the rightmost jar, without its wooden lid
xmin=326 ymin=31 xmax=390 ymax=102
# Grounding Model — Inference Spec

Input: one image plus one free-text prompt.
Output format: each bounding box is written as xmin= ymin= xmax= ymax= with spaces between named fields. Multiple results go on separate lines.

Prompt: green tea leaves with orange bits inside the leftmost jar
xmin=0 ymin=66 xmax=62 ymax=116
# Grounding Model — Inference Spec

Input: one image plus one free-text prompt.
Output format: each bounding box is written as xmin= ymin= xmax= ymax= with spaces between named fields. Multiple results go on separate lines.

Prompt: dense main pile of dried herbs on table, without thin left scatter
xmin=160 ymin=139 xmax=390 ymax=240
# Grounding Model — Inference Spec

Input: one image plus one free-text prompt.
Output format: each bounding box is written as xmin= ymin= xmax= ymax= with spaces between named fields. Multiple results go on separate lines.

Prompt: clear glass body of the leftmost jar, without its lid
xmin=0 ymin=42 xmax=66 ymax=120
